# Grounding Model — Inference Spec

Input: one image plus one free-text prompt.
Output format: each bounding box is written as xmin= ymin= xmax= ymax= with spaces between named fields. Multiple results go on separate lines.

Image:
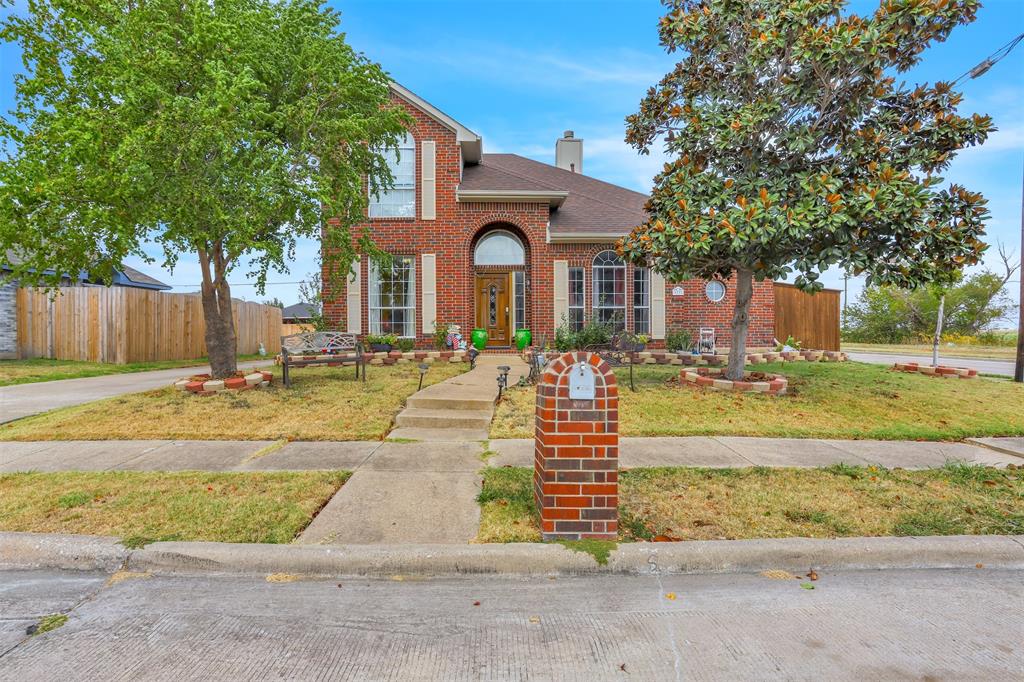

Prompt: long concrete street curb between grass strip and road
xmin=0 ymin=532 xmax=1024 ymax=577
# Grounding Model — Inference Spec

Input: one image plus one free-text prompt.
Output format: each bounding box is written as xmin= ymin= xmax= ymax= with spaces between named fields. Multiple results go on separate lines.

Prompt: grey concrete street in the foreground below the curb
xmin=0 ymin=568 xmax=1024 ymax=682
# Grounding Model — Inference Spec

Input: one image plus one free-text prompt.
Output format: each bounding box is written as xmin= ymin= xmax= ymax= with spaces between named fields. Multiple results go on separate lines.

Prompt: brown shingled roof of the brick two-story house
xmin=459 ymin=154 xmax=647 ymax=242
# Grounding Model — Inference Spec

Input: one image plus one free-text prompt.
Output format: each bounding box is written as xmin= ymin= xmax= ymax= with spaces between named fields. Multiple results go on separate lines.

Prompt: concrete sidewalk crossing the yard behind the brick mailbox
xmin=0 ymin=436 xmax=1024 ymax=471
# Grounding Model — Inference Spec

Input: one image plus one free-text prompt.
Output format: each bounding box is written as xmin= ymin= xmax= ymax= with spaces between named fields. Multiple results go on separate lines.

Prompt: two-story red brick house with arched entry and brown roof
xmin=324 ymin=84 xmax=774 ymax=347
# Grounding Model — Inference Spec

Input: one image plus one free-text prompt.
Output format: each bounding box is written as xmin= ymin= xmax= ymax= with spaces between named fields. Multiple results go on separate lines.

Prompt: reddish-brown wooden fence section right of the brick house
xmin=775 ymin=282 xmax=841 ymax=350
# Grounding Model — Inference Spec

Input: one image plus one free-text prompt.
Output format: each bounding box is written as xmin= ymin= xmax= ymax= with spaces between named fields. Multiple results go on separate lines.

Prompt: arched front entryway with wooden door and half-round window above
xmin=472 ymin=223 xmax=529 ymax=348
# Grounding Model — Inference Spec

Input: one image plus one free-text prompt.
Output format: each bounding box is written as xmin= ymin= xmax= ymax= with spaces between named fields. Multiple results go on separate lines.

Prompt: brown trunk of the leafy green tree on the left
xmin=199 ymin=245 xmax=239 ymax=379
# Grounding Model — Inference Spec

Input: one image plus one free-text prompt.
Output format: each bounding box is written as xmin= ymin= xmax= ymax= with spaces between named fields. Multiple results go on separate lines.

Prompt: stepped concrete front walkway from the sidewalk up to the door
xmin=388 ymin=354 xmax=529 ymax=441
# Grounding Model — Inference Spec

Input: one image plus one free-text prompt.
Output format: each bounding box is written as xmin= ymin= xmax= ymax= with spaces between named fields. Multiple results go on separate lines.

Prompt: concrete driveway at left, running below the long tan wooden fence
xmin=0 ymin=359 xmax=273 ymax=424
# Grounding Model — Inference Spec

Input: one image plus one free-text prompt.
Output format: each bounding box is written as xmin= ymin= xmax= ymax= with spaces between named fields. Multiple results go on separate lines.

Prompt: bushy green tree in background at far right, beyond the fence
xmin=843 ymin=241 xmax=1020 ymax=343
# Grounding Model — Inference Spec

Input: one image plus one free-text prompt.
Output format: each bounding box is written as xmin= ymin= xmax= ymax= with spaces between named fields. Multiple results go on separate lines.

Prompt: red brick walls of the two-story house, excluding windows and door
xmin=324 ymin=96 xmax=774 ymax=347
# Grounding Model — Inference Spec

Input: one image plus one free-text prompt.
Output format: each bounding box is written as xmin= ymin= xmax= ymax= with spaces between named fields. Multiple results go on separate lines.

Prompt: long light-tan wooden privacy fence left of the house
xmin=17 ymin=287 xmax=281 ymax=364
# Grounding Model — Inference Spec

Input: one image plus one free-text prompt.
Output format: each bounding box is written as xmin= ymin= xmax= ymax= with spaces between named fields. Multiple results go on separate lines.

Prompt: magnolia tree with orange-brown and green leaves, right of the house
xmin=618 ymin=0 xmax=993 ymax=379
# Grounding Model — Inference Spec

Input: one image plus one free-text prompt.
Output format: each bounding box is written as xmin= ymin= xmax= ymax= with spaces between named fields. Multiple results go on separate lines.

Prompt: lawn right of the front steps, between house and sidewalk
xmin=490 ymin=363 xmax=1024 ymax=440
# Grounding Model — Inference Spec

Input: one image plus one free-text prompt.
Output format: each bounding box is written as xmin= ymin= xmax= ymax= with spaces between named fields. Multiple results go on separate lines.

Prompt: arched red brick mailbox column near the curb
xmin=534 ymin=352 xmax=618 ymax=540
